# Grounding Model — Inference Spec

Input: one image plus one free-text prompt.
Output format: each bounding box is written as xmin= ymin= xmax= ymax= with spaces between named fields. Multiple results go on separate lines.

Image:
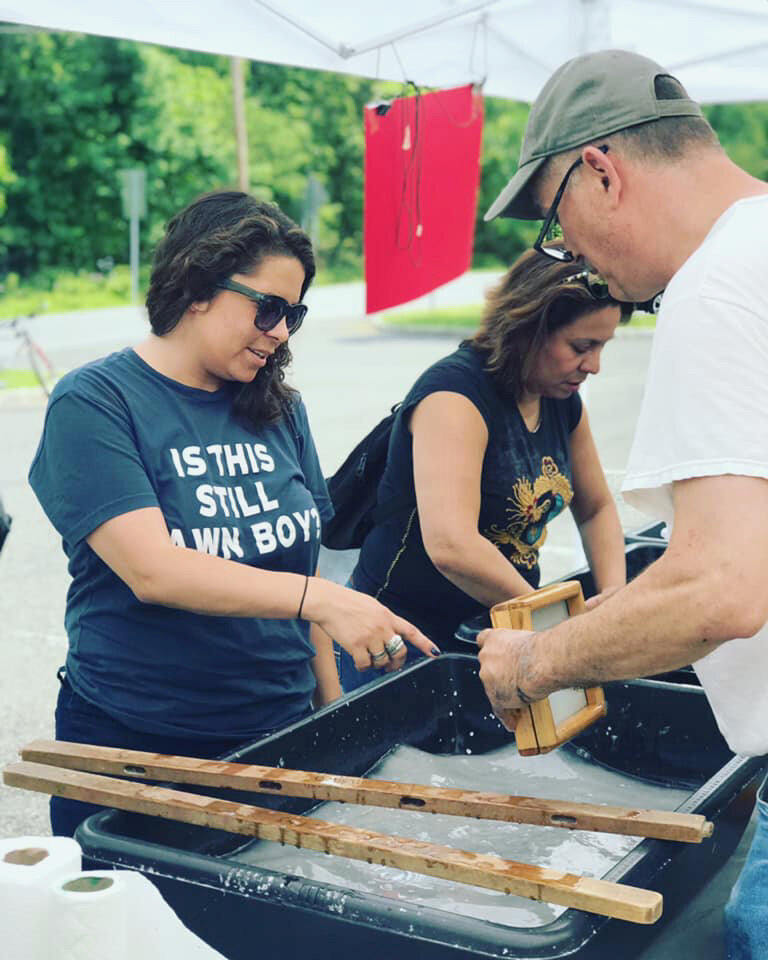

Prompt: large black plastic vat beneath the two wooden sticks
xmin=77 ymin=654 xmax=764 ymax=960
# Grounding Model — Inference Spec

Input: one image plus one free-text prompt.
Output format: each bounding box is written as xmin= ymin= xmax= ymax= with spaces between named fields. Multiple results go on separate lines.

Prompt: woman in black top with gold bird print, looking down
xmin=341 ymin=251 xmax=631 ymax=690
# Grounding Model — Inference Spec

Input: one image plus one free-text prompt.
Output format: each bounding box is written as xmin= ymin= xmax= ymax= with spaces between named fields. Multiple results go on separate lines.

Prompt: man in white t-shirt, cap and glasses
xmin=479 ymin=50 xmax=768 ymax=960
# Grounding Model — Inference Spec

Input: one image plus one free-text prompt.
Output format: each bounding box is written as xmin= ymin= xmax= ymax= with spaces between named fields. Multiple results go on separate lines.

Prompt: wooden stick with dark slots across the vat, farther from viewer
xmin=21 ymin=740 xmax=712 ymax=843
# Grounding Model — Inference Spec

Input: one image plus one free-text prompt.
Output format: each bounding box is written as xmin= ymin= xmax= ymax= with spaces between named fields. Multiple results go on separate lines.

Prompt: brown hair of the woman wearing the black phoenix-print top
xmin=469 ymin=250 xmax=631 ymax=400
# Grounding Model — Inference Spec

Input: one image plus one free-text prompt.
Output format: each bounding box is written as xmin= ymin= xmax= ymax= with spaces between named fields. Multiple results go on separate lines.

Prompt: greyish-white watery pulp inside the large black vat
xmin=237 ymin=745 xmax=689 ymax=927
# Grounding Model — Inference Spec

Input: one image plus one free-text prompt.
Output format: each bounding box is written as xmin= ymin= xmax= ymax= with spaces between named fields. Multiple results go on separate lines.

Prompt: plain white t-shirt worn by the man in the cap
xmin=623 ymin=195 xmax=768 ymax=755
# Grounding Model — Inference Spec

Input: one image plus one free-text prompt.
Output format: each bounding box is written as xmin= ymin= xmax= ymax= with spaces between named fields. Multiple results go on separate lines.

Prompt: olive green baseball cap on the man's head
xmin=484 ymin=50 xmax=702 ymax=220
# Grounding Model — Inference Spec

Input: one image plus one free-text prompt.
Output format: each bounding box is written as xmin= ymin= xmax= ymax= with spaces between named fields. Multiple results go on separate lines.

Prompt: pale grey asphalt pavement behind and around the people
xmin=0 ymin=274 xmax=751 ymax=960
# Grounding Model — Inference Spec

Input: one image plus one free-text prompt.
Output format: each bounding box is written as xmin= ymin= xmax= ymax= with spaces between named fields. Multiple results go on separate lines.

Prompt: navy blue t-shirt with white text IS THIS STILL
xmin=29 ymin=349 xmax=332 ymax=739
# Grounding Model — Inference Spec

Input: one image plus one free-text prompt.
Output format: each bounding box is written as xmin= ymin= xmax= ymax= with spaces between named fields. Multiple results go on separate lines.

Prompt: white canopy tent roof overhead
xmin=0 ymin=0 xmax=768 ymax=103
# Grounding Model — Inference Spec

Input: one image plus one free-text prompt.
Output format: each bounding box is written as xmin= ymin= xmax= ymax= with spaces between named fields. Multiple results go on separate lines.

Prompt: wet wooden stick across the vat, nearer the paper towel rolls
xmin=3 ymin=761 xmax=662 ymax=923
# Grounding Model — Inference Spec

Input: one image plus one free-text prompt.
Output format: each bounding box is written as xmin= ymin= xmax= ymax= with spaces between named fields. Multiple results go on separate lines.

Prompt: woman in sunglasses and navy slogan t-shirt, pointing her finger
xmin=30 ymin=192 xmax=438 ymax=834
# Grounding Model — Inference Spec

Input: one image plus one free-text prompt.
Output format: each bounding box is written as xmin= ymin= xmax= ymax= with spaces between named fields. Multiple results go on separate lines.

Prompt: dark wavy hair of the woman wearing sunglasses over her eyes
xmin=147 ymin=190 xmax=315 ymax=426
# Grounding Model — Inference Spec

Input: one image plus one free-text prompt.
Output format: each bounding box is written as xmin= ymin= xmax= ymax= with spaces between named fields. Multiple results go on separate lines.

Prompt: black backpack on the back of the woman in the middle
xmin=322 ymin=403 xmax=416 ymax=550
